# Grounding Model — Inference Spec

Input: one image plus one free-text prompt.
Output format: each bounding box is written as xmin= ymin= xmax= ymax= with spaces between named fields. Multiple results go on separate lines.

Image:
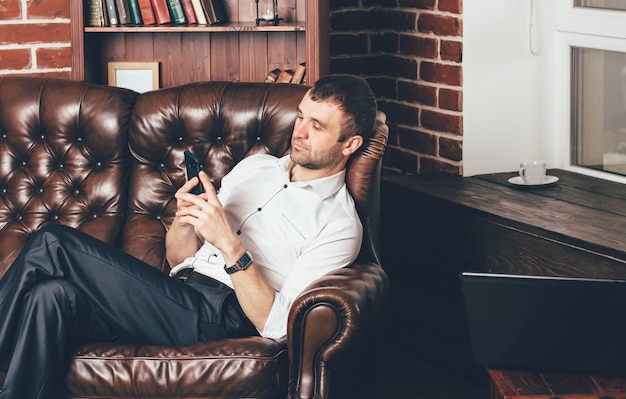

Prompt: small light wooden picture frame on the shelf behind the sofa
xmin=108 ymin=62 xmax=159 ymax=93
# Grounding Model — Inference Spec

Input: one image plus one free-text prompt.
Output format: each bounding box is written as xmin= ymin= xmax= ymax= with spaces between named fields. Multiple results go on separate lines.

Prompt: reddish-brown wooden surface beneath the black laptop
xmin=488 ymin=369 xmax=626 ymax=399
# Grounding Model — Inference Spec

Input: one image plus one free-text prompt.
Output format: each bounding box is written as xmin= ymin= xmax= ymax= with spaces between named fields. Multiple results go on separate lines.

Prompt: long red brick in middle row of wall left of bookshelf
xmin=0 ymin=23 xmax=70 ymax=44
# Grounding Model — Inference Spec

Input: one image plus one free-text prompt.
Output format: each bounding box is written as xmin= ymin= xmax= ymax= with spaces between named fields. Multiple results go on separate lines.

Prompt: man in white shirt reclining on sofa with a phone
xmin=0 ymin=75 xmax=376 ymax=399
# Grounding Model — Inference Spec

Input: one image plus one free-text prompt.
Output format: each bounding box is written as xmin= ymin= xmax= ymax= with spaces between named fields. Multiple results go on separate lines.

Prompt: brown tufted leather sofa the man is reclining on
xmin=0 ymin=77 xmax=389 ymax=398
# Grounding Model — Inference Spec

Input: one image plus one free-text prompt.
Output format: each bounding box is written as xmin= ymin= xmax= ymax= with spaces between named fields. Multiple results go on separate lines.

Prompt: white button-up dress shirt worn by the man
xmin=171 ymin=154 xmax=363 ymax=338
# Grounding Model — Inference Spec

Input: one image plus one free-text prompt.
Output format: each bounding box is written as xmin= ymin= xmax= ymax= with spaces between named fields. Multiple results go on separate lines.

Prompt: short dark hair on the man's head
xmin=310 ymin=74 xmax=378 ymax=142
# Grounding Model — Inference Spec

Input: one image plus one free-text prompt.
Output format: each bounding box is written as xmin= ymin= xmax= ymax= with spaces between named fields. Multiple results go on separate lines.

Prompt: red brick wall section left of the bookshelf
xmin=0 ymin=0 xmax=71 ymax=78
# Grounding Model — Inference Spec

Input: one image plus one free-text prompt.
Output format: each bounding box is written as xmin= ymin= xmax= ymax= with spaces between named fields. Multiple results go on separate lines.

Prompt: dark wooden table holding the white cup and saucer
xmin=381 ymin=169 xmax=626 ymax=382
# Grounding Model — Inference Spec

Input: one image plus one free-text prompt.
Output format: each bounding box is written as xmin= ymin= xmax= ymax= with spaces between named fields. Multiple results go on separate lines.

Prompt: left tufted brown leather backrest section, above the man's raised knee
xmin=0 ymin=77 xmax=137 ymax=276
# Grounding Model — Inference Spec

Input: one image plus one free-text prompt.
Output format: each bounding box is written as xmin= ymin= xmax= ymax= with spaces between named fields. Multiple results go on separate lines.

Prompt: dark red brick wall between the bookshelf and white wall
xmin=331 ymin=0 xmax=463 ymax=174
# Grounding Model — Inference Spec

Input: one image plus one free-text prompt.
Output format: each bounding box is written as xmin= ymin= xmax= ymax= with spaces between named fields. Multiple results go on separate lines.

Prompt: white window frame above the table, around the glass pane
xmin=555 ymin=0 xmax=626 ymax=183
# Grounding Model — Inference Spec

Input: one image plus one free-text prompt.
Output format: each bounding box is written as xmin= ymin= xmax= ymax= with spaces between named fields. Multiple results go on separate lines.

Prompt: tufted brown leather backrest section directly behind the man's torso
xmin=122 ymin=82 xmax=388 ymax=271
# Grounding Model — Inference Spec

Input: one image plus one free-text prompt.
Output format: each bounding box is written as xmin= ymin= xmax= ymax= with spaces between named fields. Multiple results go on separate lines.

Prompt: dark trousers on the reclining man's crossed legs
xmin=0 ymin=225 xmax=258 ymax=399
